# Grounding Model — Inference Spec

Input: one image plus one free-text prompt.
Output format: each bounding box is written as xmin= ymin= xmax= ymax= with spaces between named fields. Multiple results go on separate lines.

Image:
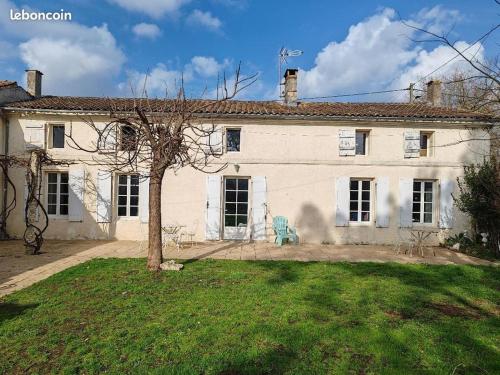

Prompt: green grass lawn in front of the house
xmin=0 ymin=259 xmax=500 ymax=374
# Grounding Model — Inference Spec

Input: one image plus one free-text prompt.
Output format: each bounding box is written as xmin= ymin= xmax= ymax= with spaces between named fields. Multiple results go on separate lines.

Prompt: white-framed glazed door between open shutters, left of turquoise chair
xmin=224 ymin=177 xmax=249 ymax=240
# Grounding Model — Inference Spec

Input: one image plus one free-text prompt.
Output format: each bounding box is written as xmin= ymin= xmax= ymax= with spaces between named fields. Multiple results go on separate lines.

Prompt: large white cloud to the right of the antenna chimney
xmin=298 ymin=7 xmax=482 ymax=101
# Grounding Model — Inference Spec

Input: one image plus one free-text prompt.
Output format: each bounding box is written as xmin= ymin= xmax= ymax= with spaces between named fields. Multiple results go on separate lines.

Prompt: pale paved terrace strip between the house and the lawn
xmin=0 ymin=240 xmax=496 ymax=297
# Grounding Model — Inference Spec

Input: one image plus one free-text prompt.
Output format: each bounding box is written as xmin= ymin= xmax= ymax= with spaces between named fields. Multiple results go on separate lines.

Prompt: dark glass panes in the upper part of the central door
xmin=224 ymin=178 xmax=248 ymax=227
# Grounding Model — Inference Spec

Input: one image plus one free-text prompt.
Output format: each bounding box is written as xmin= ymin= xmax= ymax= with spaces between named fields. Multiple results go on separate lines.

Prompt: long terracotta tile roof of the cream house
xmin=5 ymin=96 xmax=497 ymax=121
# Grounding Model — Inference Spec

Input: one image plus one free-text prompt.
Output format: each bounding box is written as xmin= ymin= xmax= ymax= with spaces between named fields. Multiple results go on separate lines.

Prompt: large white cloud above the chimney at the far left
xmin=0 ymin=0 xmax=125 ymax=95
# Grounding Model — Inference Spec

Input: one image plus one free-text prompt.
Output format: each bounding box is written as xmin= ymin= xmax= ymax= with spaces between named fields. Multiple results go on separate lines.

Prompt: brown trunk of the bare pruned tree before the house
xmin=148 ymin=173 xmax=163 ymax=271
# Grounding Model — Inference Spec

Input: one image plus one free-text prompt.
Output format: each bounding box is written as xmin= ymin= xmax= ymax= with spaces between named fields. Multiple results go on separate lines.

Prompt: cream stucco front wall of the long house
xmin=1 ymin=114 xmax=489 ymax=243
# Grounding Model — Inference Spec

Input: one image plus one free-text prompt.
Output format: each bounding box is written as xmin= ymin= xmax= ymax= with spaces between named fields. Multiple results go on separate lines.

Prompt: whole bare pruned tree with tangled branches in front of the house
xmin=67 ymin=64 xmax=256 ymax=271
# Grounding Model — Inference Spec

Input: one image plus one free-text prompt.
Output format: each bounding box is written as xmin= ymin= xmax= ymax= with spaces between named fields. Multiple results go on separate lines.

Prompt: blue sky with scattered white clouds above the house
xmin=0 ymin=0 xmax=500 ymax=102
